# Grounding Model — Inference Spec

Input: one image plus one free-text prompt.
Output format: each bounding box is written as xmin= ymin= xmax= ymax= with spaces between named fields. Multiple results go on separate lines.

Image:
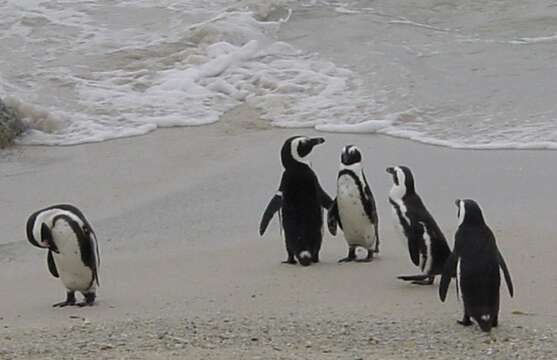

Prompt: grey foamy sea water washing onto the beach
xmin=0 ymin=0 xmax=557 ymax=149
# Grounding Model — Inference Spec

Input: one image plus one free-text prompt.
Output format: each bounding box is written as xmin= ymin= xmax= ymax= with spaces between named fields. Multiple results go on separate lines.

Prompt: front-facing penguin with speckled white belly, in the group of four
xmin=327 ymin=145 xmax=379 ymax=262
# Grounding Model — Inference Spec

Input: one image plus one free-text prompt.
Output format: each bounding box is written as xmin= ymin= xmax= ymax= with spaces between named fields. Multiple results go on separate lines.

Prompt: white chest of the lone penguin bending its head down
xmin=52 ymin=223 xmax=95 ymax=291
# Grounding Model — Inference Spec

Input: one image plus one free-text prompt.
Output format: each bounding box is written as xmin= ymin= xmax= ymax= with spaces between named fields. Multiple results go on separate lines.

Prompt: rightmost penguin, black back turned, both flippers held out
xmin=439 ymin=200 xmax=514 ymax=332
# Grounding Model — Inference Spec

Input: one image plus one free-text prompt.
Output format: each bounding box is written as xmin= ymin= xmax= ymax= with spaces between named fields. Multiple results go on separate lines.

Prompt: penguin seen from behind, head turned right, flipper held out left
xmin=259 ymin=136 xmax=332 ymax=266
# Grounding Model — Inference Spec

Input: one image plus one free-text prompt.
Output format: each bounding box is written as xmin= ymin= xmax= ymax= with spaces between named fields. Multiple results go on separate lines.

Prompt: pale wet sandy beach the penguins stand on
xmin=0 ymin=107 xmax=557 ymax=359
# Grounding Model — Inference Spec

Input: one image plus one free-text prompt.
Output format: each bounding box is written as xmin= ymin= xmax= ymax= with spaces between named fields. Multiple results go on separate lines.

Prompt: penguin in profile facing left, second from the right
xmin=387 ymin=166 xmax=451 ymax=285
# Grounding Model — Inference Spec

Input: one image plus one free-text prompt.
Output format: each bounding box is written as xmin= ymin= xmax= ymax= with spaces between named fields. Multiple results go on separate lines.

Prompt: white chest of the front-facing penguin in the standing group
xmin=337 ymin=175 xmax=375 ymax=249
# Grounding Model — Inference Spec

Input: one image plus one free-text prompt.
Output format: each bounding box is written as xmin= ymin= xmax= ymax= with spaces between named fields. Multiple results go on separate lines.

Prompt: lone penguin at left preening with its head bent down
xmin=26 ymin=204 xmax=100 ymax=307
